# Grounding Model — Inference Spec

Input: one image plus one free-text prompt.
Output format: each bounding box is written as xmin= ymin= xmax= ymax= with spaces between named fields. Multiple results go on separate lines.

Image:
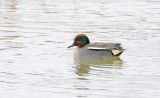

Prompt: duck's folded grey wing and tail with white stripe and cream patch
xmin=88 ymin=43 xmax=124 ymax=56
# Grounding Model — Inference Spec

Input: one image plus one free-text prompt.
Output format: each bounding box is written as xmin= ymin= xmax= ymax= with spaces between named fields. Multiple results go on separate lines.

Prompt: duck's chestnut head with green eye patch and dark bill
xmin=68 ymin=34 xmax=90 ymax=48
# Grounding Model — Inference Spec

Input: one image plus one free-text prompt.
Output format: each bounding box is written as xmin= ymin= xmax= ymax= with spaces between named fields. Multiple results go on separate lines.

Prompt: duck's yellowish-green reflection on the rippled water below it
xmin=74 ymin=57 xmax=123 ymax=75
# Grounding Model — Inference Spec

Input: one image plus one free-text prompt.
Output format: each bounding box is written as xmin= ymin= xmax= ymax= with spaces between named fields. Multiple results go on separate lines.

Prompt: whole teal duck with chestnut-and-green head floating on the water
xmin=68 ymin=34 xmax=124 ymax=58
